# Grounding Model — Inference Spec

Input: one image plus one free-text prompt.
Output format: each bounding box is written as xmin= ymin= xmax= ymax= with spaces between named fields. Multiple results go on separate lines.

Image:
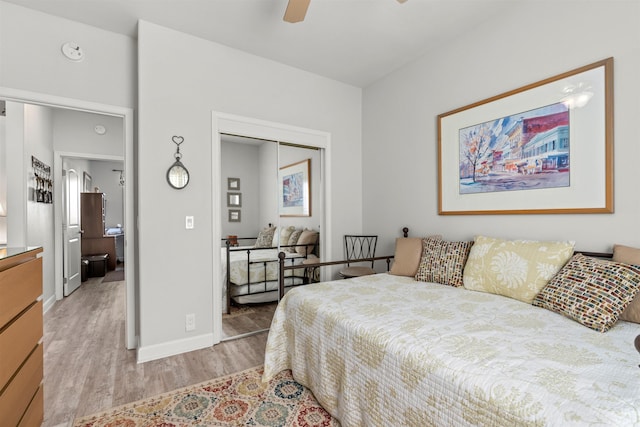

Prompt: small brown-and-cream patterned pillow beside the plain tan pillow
xmin=416 ymin=237 xmax=473 ymax=287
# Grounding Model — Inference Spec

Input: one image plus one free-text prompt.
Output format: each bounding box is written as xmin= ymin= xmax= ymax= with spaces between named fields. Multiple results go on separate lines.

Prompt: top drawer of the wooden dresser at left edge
xmin=0 ymin=258 xmax=42 ymax=328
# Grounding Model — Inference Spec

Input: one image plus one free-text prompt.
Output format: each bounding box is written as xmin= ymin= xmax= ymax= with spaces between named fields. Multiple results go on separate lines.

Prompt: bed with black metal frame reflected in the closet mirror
xmin=221 ymin=226 xmax=317 ymax=313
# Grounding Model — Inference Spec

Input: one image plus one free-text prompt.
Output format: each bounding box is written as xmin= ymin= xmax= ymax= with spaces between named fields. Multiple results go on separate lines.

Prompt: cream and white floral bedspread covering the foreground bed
xmin=264 ymin=274 xmax=640 ymax=426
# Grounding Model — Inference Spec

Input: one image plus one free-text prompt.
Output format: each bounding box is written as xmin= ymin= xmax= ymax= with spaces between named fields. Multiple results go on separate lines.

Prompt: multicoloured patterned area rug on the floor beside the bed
xmin=73 ymin=367 xmax=340 ymax=427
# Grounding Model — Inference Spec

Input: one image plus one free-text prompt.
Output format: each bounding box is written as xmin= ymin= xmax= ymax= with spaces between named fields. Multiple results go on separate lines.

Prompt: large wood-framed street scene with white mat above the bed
xmin=438 ymin=58 xmax=613 ymax=215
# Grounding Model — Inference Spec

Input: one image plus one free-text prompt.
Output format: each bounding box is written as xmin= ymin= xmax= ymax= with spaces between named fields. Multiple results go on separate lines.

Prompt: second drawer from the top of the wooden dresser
xmin=0 ymin=301 xmax=42 ymax=386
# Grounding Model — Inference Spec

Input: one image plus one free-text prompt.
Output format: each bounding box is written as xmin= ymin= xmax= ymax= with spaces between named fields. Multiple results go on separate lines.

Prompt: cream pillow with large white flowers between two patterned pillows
xmin=463 ymin=236 xmax=574 ymax=304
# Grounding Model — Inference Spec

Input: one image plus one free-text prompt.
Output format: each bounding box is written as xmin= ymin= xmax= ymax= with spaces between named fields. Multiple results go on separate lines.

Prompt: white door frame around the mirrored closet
xmin=211 ymin=111 xmax=332 ymax=344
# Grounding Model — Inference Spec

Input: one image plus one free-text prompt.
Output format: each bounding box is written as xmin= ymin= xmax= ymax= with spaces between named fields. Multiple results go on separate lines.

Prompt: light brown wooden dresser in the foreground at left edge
xmin=0 ymin=248 xmax=44 ymax=427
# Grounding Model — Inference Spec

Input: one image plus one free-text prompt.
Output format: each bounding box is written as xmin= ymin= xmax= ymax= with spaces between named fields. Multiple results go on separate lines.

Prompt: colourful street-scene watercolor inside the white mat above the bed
xmin=459 ymin=102 xmax=571 ymax=194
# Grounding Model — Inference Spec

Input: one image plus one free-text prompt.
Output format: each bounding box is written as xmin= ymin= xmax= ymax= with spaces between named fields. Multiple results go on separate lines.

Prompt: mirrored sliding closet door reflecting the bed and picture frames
xmin=220 ymin=135 xmax=323 ymax=340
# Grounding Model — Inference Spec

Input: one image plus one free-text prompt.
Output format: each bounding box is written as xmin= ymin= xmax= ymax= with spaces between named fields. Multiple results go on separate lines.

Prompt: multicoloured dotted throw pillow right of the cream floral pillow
xmin=533 ymin=254 xmax=640 ymax=332
